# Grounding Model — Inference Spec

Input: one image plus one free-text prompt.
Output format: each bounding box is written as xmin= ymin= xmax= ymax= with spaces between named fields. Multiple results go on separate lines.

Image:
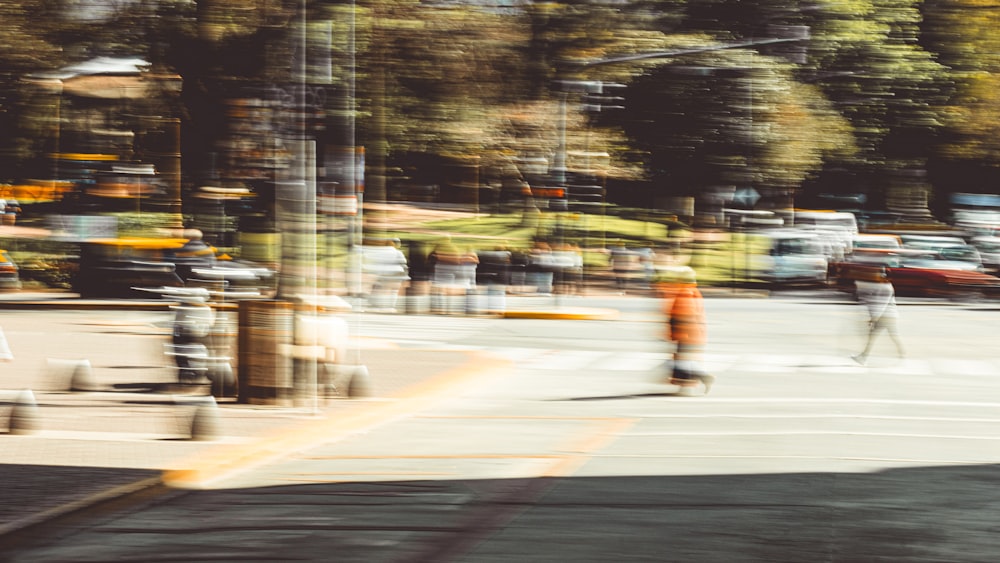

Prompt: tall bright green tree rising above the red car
xmin=806 ymin=0 xmax=952 ymax=208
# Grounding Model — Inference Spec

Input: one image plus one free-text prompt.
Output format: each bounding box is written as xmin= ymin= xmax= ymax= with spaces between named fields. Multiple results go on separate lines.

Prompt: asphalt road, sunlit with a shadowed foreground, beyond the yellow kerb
xmin=1 ymin=298 xmax=1000 ymax=562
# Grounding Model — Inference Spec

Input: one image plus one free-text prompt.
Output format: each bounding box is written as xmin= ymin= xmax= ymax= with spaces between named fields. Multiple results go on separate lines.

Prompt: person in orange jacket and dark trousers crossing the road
xmin=658 ymin=268 xmax=715 ymax=394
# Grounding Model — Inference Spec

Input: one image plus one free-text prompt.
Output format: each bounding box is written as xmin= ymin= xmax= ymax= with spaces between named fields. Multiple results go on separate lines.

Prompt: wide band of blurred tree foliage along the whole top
xmin=0 ymin=0 xmax=1000 ymax=212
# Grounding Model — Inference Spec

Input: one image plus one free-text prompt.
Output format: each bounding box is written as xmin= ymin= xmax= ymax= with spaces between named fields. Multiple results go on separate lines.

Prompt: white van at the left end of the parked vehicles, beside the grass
xmin=746 ymin=229 xmax=829 ymax=284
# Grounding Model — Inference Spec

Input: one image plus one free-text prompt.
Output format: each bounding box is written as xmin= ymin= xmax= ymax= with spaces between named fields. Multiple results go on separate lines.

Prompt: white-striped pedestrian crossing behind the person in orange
xmin=492 ymin=348 xmax=1000 ymax=378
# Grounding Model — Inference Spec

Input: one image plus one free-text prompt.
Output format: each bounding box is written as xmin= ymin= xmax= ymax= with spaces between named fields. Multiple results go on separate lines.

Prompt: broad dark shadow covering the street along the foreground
xmin=0 ymin=459 xmax=1000 ymax=563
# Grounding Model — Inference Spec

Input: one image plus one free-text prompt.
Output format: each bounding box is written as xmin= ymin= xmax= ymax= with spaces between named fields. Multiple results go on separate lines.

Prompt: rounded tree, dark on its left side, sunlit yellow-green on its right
xmin=623 ymin=50 xmax=854 ymax=204
